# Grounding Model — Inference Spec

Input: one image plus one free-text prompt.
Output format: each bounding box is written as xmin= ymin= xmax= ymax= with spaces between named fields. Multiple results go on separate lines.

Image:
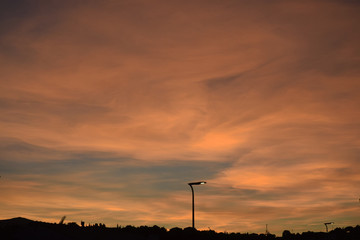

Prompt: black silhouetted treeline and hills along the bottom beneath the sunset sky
xmin=0 ymin=218 xmax=360 ymax=240
